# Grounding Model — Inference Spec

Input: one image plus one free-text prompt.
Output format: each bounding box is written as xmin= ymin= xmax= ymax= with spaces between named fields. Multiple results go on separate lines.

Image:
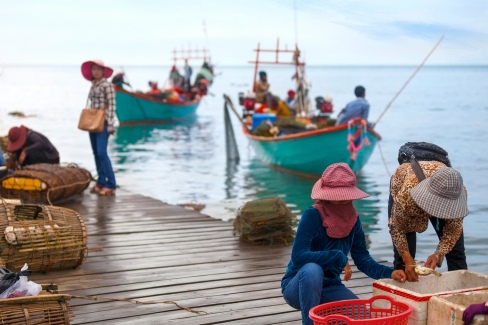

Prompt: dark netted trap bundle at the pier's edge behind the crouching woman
xmin=233 ymin=197 xmax=298 ymax=244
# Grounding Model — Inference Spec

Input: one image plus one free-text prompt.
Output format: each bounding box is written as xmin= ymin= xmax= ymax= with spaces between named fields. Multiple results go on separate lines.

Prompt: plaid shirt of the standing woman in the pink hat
xmin=88 ymin=78 xmax=115 ymax=125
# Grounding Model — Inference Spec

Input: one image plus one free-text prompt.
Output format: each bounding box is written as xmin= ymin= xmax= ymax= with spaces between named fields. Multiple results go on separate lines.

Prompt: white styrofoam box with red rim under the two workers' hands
xmin=373 ymin=270 xmax=488 ymax=325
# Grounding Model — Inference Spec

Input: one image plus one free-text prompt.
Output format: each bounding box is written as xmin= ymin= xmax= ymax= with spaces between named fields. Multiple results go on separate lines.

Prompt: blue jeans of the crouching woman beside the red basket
xmin=283 ymin=263 xmax=358 ymax=325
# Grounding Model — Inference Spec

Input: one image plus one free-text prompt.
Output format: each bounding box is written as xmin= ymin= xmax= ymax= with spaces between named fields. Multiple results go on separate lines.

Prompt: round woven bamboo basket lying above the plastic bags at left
xmin=0 ymin=199 xmax=88 ymax=270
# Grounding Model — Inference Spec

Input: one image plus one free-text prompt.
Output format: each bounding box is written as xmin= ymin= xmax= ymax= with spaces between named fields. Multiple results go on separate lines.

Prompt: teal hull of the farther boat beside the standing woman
xmin=115 ymin=87 xmax=200 ymax=125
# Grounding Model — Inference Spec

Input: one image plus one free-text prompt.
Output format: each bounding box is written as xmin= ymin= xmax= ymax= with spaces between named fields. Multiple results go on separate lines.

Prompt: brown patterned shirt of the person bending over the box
xmin=388 ymin=161 xmax=466 ymax=266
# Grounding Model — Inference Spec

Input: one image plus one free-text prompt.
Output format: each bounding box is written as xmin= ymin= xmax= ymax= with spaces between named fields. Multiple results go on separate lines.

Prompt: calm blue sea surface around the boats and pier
xmin=0 ymin=66 xmax=488 ymax=274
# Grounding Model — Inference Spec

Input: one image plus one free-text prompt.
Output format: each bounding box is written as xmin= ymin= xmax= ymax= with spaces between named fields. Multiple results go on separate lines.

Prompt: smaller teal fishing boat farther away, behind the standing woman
xmin=112 ymin=49 xmax=213 ymax=125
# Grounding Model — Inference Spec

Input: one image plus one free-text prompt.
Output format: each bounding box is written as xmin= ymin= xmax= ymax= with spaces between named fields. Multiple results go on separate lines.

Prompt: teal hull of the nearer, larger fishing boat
xmin=244 ymin=125 xmax=377 ymax=174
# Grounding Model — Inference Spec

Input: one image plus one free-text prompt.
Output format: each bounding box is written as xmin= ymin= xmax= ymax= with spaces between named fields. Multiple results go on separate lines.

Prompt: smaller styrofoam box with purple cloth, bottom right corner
xmin=427 ymin=290 xmax=488 ymax=325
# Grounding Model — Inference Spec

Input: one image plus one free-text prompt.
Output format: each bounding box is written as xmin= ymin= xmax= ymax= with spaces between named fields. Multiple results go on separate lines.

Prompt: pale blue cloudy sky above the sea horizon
xmin=0 ymin=0 xmax=488 ymax=66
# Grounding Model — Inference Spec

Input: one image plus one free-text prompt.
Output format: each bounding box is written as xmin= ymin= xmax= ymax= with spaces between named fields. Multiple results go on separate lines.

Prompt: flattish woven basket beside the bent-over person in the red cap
xmin=0 ymin=164 xmax=92 ymax=204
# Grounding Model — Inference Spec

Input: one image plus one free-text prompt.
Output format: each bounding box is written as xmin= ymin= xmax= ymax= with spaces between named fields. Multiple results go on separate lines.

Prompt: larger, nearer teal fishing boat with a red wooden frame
xmin=224 ymin=41 xmax=381 ymax=174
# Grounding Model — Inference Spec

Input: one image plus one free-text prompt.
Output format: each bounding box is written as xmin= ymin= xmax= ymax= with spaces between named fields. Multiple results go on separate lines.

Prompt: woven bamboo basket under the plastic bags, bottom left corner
xmin=0 ymin=284 xmax=74 ymax=325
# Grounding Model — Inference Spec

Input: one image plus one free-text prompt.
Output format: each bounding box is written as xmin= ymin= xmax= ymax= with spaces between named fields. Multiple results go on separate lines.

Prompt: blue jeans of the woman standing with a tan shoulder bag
xmin=89 ymin=121 xmax=116 ymax=190
